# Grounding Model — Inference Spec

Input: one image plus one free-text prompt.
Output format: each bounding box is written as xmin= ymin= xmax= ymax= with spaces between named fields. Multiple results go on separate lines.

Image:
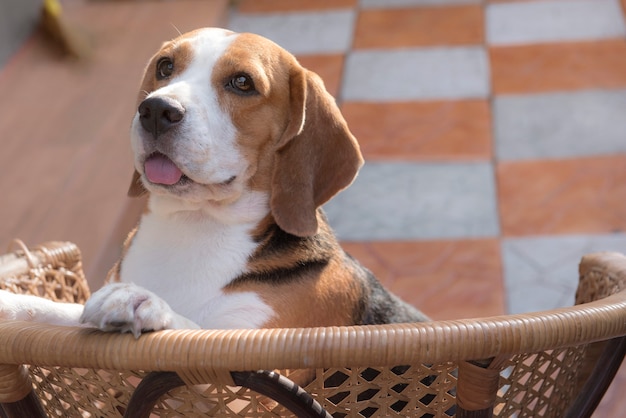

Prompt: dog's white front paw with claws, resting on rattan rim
xmin=80 ymin=283 xmax=175 ymax=338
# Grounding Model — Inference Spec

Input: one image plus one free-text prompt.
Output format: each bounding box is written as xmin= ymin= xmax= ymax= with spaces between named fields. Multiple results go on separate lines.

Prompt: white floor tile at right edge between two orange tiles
xmin=493 ymin=90 xmax=626 ymax=160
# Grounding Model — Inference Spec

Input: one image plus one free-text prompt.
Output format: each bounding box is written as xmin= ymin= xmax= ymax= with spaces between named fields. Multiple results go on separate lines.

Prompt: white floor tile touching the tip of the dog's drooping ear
xmin=325 ymin=162 xmax=499 ymax=240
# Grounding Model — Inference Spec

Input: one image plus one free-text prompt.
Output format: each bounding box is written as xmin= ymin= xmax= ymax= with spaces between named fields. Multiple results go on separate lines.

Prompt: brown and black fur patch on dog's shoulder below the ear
xmin=224 ymin=214 xmax=363 ymax=328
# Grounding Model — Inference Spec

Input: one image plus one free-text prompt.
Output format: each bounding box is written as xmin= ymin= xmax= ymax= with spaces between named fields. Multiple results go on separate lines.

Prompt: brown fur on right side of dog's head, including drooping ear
xmin=211 ymin=34 xmax=363 ymax=236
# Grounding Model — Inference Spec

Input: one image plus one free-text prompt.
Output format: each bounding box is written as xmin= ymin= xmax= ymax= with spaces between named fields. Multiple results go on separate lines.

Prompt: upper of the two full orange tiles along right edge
xmin=489 ymin=39 xmax=626 ymax=93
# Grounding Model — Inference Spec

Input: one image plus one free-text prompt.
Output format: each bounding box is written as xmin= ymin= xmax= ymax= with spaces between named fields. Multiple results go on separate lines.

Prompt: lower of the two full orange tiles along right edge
xmin=497 ymin=155 xmax=626 ymax=236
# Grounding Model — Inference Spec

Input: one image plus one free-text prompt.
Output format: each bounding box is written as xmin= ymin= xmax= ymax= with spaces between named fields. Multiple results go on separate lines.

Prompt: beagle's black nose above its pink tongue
xmin=137 ymin=97 xmax=185 ymax=139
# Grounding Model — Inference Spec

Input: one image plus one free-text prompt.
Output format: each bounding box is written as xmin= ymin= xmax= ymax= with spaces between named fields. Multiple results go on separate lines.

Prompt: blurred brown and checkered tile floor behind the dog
xmin=0 ymin=0 xmax=626 ymax=417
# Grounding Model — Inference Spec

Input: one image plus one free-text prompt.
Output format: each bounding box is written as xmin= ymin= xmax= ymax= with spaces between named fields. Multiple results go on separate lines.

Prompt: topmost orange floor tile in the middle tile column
xmin=354 ymin=5 xmax=484 ymax=49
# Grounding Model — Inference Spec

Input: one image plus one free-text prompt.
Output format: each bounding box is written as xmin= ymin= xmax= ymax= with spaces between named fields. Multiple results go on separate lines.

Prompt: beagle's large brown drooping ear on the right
xmin=270 ymin=64 xmax=363 ymax=237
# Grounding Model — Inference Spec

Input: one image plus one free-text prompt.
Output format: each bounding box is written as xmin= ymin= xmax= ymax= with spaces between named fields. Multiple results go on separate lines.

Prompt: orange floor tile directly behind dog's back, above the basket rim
xmin=343 ymin=239 xmax=505 ymax=319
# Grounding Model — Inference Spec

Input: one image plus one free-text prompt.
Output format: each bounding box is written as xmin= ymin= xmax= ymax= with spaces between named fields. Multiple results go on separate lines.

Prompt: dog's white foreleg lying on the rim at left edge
xmin=0 ymin=290 xmax=83 ymax=326
